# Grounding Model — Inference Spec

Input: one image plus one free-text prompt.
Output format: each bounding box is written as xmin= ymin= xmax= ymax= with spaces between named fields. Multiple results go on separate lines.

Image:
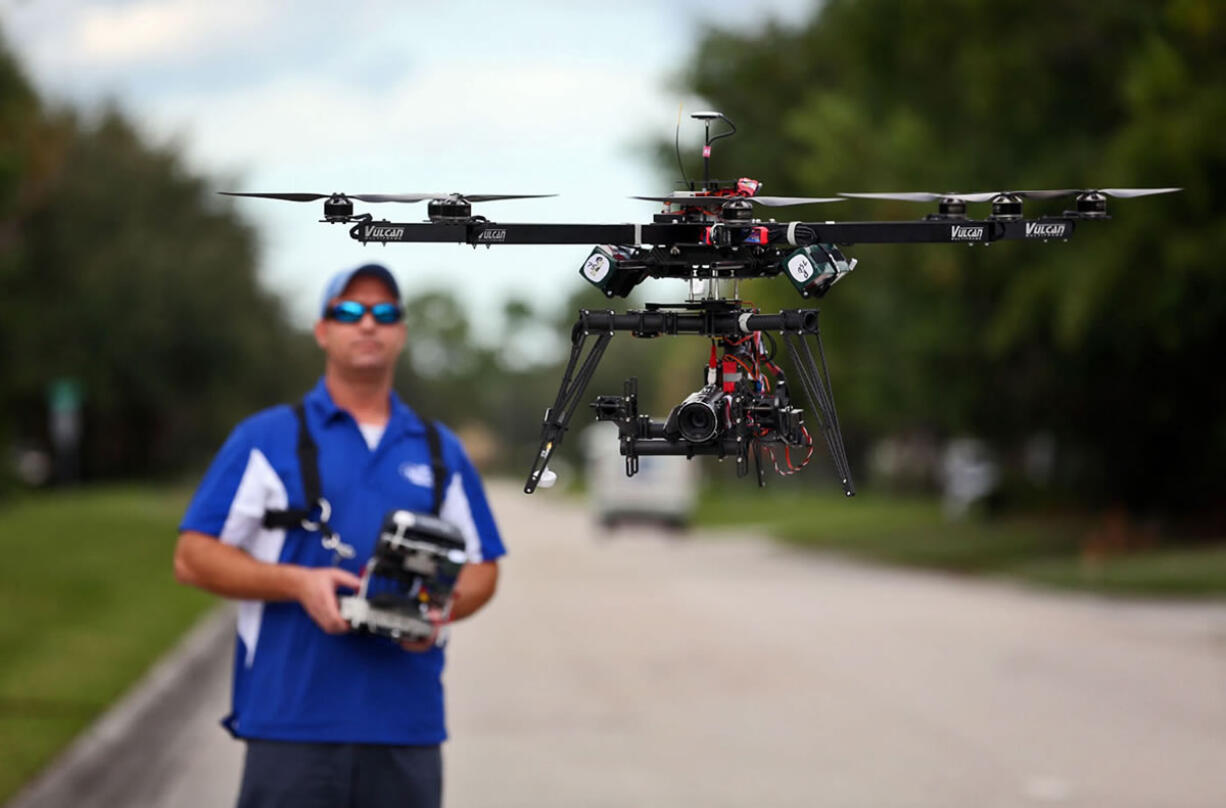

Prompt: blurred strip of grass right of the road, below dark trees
xmin=699 ymin=487 xmax=1226 ymax=597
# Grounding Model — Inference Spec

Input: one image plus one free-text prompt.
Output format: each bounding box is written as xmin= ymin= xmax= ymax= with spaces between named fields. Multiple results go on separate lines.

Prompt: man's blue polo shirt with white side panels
xmin=179 ymin=380 xmax=505 ymax=744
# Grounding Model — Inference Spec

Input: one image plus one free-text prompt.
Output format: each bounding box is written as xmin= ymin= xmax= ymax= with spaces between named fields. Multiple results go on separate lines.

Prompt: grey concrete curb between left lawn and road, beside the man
xmin=5 ymin=604 xmax=234 ymax=808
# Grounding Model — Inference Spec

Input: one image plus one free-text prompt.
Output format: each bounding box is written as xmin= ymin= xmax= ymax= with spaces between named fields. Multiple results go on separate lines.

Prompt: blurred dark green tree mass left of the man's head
xmin=0 ymin=39 xmax=315 ymax=477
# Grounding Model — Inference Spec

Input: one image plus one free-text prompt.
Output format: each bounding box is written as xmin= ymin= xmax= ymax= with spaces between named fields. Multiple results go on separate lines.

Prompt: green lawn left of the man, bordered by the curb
xmin=0 ymin=487 xmax=212 ymax=803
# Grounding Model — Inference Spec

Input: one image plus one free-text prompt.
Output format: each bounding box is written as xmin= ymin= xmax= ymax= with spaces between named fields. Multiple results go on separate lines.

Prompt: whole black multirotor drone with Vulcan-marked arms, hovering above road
xmin=229 ymin=112 xmax=1181 ymax=497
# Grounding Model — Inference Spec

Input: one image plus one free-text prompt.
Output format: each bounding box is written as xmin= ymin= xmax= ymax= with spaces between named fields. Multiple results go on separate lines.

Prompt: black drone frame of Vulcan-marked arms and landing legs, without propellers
xmin=325 ymin=212 xmax=1081 ymax=497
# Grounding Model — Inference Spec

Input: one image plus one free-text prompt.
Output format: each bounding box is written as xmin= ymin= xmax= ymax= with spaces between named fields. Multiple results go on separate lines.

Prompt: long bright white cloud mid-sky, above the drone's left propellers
xmin=145 ymin=63 xmax=676 ymax=174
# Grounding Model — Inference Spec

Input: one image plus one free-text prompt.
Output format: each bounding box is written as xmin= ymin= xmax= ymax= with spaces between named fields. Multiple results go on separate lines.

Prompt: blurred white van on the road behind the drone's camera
xmin=580 ymin=422 xmax=699 ymax=527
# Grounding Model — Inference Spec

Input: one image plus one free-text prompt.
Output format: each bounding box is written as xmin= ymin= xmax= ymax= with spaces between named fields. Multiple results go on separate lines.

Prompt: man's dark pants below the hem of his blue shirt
xmin=238 ymin=741 xmax=443 ymax=808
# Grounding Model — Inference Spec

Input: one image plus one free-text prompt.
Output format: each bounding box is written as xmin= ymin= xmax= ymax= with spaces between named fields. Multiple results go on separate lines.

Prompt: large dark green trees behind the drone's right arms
xmin=669 ymin=0 xmax=1226 ymax=511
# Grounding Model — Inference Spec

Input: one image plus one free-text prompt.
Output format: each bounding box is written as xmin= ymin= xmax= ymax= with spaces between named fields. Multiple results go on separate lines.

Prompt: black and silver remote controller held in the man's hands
xmin=341 ymin=510 xmax=468 ymax=640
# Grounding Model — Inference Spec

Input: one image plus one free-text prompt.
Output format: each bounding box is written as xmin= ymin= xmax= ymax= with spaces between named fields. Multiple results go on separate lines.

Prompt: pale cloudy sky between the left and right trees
xmin=0 ymin=0 xmax=813 ymax=341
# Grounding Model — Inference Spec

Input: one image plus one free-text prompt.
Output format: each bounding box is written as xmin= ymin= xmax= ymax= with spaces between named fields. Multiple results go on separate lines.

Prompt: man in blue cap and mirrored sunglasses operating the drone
xmin=174 ymin=264 xmax=505 ymax=808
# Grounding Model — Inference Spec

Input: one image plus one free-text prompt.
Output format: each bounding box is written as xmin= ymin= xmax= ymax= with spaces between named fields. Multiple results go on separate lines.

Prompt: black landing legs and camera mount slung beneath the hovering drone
xmin=524 ymin=300 xmax=856 ymax=497
